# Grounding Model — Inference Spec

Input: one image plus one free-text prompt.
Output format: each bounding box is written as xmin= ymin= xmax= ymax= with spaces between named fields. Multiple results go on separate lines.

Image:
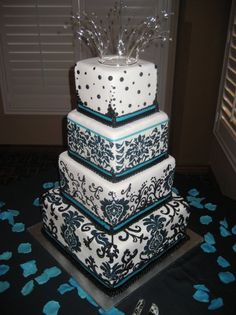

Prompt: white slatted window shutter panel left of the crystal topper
xmin=0 ymin=0 xmax=76 ymax=114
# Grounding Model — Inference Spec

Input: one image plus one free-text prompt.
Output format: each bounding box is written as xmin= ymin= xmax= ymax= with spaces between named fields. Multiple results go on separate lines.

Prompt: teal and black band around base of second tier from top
xmin=69 ymin=149 xmax=167 ymax=177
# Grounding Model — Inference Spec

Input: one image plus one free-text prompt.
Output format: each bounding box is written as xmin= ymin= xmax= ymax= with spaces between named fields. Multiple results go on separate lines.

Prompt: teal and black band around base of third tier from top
xmin=61 ymin=190 xmax=171 ymax=231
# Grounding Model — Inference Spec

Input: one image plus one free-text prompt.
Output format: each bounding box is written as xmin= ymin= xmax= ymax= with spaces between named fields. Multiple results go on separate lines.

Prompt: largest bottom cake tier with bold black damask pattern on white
xmin=42 ymin=189 xmax=189 ymax=290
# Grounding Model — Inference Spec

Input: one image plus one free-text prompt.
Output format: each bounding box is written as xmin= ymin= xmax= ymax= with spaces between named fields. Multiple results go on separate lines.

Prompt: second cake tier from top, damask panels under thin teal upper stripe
xmin=67 ymin=110 xmax=168 ymax=181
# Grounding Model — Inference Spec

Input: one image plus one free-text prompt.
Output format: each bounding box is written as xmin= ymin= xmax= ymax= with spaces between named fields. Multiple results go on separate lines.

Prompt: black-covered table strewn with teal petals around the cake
xmin=0 ymin=171 xmax=236 ymax=315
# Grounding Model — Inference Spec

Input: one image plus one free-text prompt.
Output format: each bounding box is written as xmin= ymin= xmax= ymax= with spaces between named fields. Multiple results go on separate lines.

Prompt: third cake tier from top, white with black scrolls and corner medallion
xmin=59 ymin=151 xmax=175 ymax=231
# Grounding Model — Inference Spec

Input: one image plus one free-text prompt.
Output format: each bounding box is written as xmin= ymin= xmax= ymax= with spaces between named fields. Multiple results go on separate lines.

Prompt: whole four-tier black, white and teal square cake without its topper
xmin=43 ymin=58 xmax=189 ymax=289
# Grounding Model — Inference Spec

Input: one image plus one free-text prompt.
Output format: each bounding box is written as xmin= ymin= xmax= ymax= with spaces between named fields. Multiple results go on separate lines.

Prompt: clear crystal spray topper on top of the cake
xmin=72 ymin=1 xmax=169 ymax=66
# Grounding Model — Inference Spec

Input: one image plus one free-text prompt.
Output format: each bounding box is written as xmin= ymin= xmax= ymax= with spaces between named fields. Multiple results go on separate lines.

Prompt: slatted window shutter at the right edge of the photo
xmin=214 ymin=1 xmax=236 ymax=170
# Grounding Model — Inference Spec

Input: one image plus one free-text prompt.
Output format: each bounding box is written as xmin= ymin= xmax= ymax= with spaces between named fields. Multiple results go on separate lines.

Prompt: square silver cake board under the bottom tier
xmin=28 ymin=223 xmax=202 ymax=310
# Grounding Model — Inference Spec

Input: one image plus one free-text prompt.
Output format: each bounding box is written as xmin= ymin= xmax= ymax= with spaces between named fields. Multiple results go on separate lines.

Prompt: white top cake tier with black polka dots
xmin=75 ymin=58 xmax=158 ymax=127
